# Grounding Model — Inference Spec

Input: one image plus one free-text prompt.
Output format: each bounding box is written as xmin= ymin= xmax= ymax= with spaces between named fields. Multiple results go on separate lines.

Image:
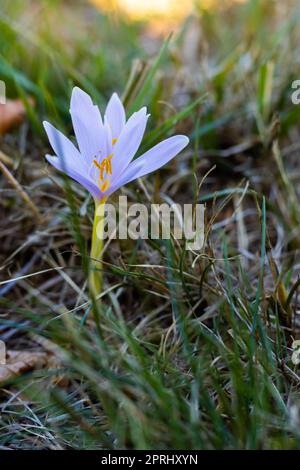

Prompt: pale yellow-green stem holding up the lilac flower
xmin=89 ymin=198 xmax=106 ymax=297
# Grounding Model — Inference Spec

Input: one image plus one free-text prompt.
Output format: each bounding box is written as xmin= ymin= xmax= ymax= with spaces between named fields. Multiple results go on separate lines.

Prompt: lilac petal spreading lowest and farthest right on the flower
xmin=120 ymin=135 xmax=189 ymax=182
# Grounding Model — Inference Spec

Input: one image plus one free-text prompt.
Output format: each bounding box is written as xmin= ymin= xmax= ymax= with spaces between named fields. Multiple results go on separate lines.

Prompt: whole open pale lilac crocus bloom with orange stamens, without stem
xmin=44 ymin=87 xmax=189 ymax=201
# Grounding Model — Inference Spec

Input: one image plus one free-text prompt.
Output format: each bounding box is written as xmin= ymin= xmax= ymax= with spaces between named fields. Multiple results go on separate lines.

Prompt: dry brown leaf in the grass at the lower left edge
xmin=0 ymin=351 xmax=49 ymax=384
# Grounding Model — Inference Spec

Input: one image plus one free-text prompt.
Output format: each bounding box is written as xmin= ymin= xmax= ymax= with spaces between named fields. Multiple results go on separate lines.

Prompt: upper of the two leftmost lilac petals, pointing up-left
xmin=43 ymin=121 xmax=86 ymax=171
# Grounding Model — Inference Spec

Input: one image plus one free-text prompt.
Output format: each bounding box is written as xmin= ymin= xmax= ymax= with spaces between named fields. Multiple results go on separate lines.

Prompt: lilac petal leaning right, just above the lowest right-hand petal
xmin=112 ymin=108 xmax=149 ymax=182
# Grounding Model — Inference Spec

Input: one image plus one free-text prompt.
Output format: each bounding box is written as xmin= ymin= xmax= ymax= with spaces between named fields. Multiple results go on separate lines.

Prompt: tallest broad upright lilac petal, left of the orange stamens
xmin=70 ymin=87 xmax=107 ymax=162
